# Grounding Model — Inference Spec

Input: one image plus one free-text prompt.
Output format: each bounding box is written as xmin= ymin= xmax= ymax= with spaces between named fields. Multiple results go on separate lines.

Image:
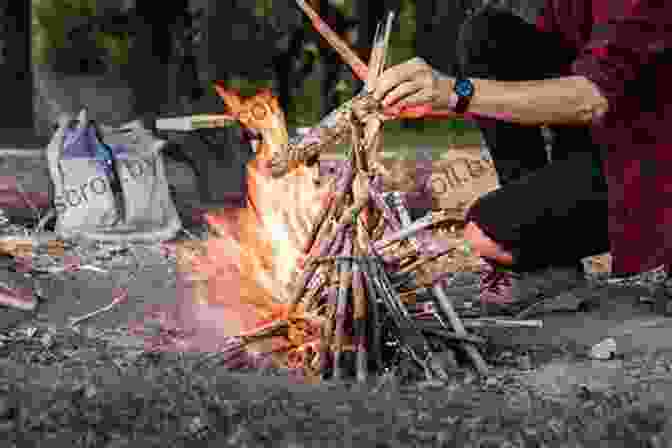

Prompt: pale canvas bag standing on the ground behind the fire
xmin=47 ymin=110 xmax=182 ymax=242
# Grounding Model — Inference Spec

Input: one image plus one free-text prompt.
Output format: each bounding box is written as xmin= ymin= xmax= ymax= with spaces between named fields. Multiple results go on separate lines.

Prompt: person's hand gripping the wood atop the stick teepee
xmin=373 ymin=57 xmax=442 ymax=110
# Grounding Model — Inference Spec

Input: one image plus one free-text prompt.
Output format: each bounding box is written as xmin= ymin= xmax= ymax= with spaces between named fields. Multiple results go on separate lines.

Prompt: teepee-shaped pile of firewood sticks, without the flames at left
xmin=193 ymin=0 xmax=540 ymax=382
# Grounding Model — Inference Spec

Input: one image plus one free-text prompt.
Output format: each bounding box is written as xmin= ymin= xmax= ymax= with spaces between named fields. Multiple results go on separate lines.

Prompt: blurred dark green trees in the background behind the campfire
xmin=23 ymin=0 xmax=543 ymax=144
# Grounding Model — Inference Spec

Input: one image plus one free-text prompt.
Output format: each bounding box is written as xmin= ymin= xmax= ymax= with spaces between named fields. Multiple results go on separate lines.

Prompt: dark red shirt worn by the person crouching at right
xmin=537 ymin=0 xmax=672 ymax=273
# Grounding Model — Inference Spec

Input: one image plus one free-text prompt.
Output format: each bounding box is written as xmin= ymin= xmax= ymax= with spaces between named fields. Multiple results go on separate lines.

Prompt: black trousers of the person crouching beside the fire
xmin=457 ymin=7 xmax=609 ymax=271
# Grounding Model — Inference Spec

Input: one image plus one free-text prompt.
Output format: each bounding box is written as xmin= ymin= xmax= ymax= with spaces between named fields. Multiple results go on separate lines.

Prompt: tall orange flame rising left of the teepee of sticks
xmin=175 ymin=84 xmax=327 ymax=349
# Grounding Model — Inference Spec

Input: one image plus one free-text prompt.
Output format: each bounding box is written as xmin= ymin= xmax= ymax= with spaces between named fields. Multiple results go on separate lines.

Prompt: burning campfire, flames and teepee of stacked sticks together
xmin=179 ymin=1 xmax=540 ymax=381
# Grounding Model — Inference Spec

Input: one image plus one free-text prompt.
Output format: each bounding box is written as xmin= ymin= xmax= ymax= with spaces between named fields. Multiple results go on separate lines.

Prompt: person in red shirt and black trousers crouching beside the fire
xmin=373 ymin=0 xmax=672 ymax=314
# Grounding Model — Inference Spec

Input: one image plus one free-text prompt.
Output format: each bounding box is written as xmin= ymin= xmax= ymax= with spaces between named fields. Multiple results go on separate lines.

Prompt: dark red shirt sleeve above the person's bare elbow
xmin=572 ymin=0 xmax=672 ymax=115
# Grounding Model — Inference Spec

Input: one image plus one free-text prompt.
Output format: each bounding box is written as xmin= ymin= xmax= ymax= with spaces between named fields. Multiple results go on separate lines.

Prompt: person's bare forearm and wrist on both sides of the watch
xmin=435 ymin=76 xmax=608 ymax=126
